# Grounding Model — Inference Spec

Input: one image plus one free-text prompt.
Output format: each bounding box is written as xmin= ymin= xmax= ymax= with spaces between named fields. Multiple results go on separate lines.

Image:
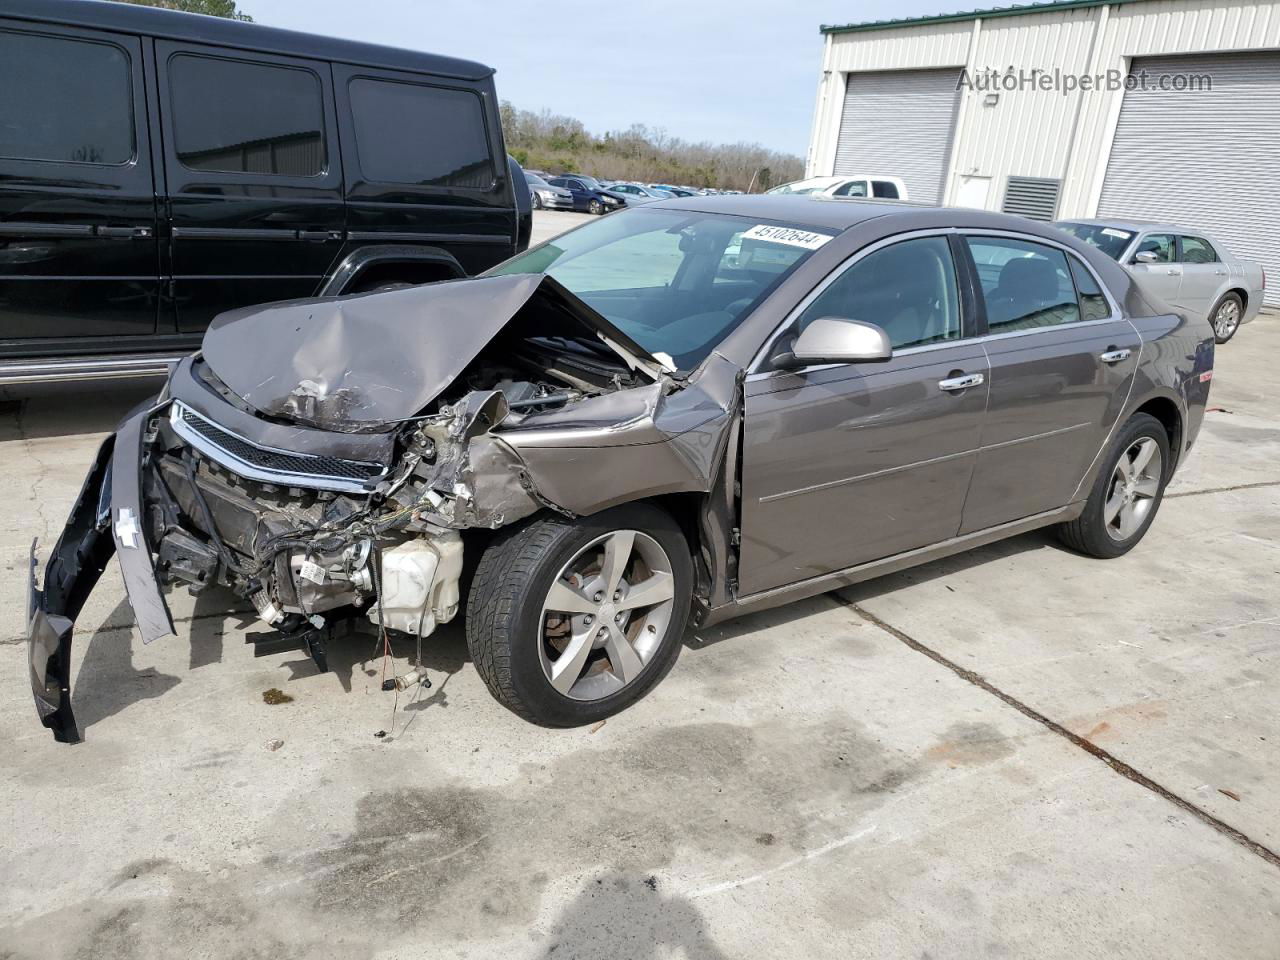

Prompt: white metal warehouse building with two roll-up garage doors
xmin=808 ymin=0 xmax=1280 ymax=303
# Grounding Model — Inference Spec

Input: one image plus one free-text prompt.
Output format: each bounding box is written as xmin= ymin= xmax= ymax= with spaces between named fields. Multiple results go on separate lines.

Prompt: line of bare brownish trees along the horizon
xmin=502 ymin=100 xmax=804 ymax=192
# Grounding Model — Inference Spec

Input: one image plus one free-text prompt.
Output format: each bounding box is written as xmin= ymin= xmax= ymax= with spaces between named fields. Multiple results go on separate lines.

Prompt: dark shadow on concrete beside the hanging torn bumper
xmin=72 ymin=600 xmax=182 ymax=736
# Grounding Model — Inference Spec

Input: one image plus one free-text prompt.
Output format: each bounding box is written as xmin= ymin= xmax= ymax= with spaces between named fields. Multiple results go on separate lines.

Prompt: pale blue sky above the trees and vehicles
xmin=239 ymin=0 xmax=962 ymax=156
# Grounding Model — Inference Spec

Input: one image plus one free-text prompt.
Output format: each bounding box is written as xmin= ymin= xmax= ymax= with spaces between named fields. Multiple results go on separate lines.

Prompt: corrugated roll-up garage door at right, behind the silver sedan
xmin=1098 ymin=52 xmax=1280 ymax=303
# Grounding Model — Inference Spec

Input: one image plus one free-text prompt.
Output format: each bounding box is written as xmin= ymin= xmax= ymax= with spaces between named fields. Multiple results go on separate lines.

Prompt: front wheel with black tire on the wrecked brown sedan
xmin=466 ymin=503 xmax=692 ymax=727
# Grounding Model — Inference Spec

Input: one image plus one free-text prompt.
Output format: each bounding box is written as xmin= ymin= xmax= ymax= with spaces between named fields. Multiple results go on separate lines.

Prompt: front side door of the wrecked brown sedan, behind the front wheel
xmin=739 ymin=237 xmax=987 ymax=595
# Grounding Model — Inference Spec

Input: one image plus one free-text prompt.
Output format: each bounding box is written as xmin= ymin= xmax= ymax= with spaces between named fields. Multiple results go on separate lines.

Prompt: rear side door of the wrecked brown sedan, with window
xmin=960 ymin=234 xmax=1142 ymax=534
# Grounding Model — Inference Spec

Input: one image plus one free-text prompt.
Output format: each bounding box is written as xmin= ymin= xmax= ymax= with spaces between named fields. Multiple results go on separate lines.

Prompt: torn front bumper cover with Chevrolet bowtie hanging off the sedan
xmin=27 ymin=404 xmax=174 ymax=744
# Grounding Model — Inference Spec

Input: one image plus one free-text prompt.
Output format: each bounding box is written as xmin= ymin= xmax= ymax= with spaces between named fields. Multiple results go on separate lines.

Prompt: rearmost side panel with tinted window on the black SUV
xmin=333 ymin=64 xmax=517 ymax=274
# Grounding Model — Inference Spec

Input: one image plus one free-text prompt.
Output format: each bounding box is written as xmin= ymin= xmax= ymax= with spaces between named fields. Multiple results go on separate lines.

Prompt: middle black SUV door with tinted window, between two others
xmin=156 ymin=41 xmax=346 ymax=333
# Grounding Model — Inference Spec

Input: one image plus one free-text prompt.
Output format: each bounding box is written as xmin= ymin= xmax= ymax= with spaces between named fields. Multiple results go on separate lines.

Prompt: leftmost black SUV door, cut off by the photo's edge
xmin=0 ymin=19 xmax=160 ymax=352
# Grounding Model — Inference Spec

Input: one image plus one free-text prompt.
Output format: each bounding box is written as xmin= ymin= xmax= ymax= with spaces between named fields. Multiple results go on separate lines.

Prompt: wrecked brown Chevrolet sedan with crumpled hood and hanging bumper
xmin=28 ymin=197 xmax=1212 ymax=741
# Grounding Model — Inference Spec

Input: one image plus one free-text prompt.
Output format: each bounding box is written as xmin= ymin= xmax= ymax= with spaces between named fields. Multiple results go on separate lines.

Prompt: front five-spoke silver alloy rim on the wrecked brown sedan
xmin=538 ymin=530 xmax=676 ymax=700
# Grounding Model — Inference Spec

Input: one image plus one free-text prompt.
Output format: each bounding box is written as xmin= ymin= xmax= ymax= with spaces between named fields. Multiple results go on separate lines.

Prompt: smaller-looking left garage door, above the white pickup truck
xmin=833 ymin=70 xmax=960 ymax=204
